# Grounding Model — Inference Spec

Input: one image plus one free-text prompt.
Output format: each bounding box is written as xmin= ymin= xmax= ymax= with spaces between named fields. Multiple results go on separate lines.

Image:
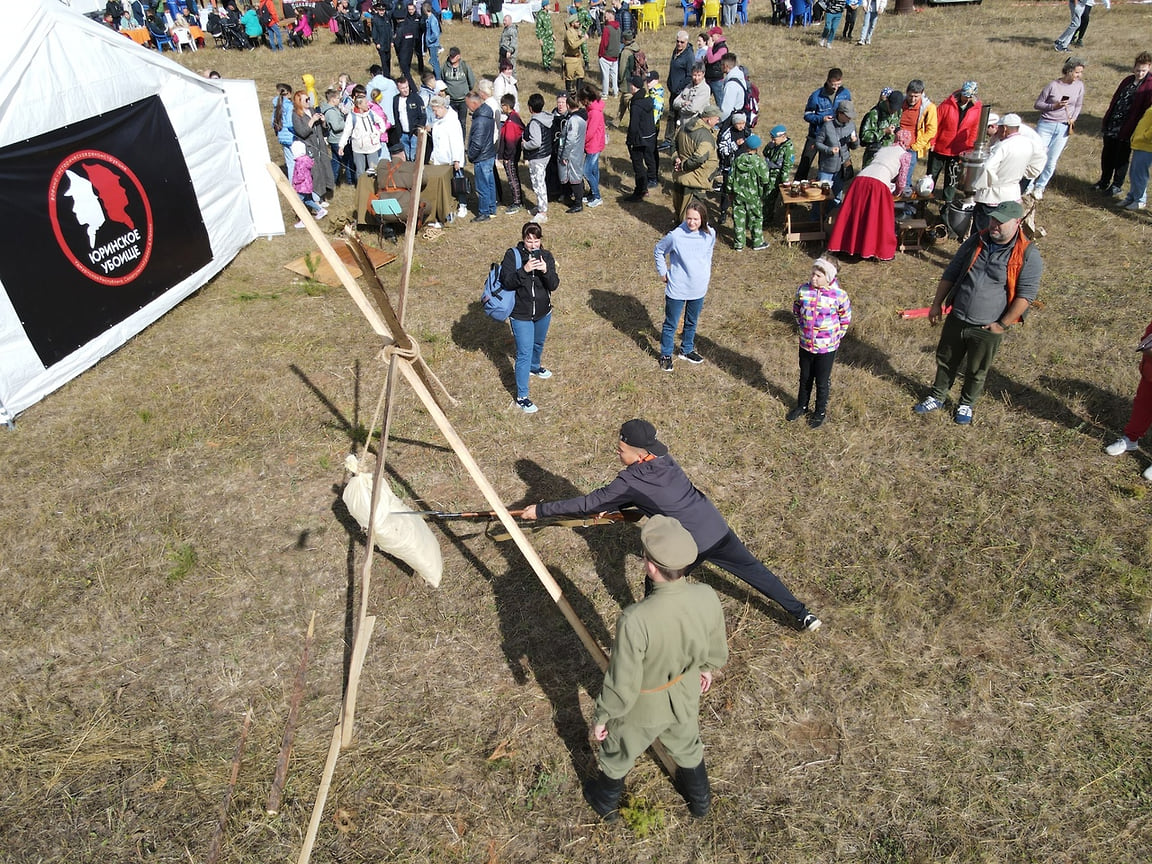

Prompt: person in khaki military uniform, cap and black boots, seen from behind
xmin=584 ymin=516 xmax=728 ymax=821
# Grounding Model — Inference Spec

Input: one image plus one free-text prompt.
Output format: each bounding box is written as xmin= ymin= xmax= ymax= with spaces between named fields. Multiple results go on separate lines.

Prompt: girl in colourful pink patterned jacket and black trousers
xmin=787 ymin=258 xmax=852 ymax=429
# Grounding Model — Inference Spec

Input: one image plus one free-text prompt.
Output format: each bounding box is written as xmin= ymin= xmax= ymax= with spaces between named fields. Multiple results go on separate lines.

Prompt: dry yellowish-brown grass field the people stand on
xmin=0 ymin=0 xmax=1152 ymax=864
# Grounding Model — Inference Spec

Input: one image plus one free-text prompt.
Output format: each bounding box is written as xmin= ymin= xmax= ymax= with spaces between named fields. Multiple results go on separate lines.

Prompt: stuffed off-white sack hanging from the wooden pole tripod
xmin=343 ymin=456 xmax=444 ymax=588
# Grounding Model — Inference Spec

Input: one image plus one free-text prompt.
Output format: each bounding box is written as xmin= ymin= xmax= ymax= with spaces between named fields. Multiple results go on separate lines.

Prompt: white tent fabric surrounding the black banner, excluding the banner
xmin=0 ymin=0 xmax=276 ymax=419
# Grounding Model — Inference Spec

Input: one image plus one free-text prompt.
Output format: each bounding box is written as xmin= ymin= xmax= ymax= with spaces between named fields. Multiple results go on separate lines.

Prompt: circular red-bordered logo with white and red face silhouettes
xmin=48 ymin=150 xmax=154 ymax=286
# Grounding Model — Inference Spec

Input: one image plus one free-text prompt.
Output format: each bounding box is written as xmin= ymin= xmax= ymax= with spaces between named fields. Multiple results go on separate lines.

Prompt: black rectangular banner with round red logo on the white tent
xmin=0 ymin=96 xmax=212 ymax=366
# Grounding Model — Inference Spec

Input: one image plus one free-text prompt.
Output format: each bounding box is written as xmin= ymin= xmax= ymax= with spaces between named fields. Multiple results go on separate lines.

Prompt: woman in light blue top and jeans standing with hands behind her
xmin=655 ymin=200 xmax=717 ymax=372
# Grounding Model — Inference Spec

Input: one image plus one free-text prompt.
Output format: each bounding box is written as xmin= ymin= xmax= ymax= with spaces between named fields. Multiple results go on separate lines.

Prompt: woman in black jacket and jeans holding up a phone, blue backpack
xmin=500 ymin=222 xmax=560 ymax=414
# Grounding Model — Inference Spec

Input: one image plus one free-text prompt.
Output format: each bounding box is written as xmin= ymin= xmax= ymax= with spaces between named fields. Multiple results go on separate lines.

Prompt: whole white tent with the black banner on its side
xmin=0 ymin=0 xmax=283 ymax=420
